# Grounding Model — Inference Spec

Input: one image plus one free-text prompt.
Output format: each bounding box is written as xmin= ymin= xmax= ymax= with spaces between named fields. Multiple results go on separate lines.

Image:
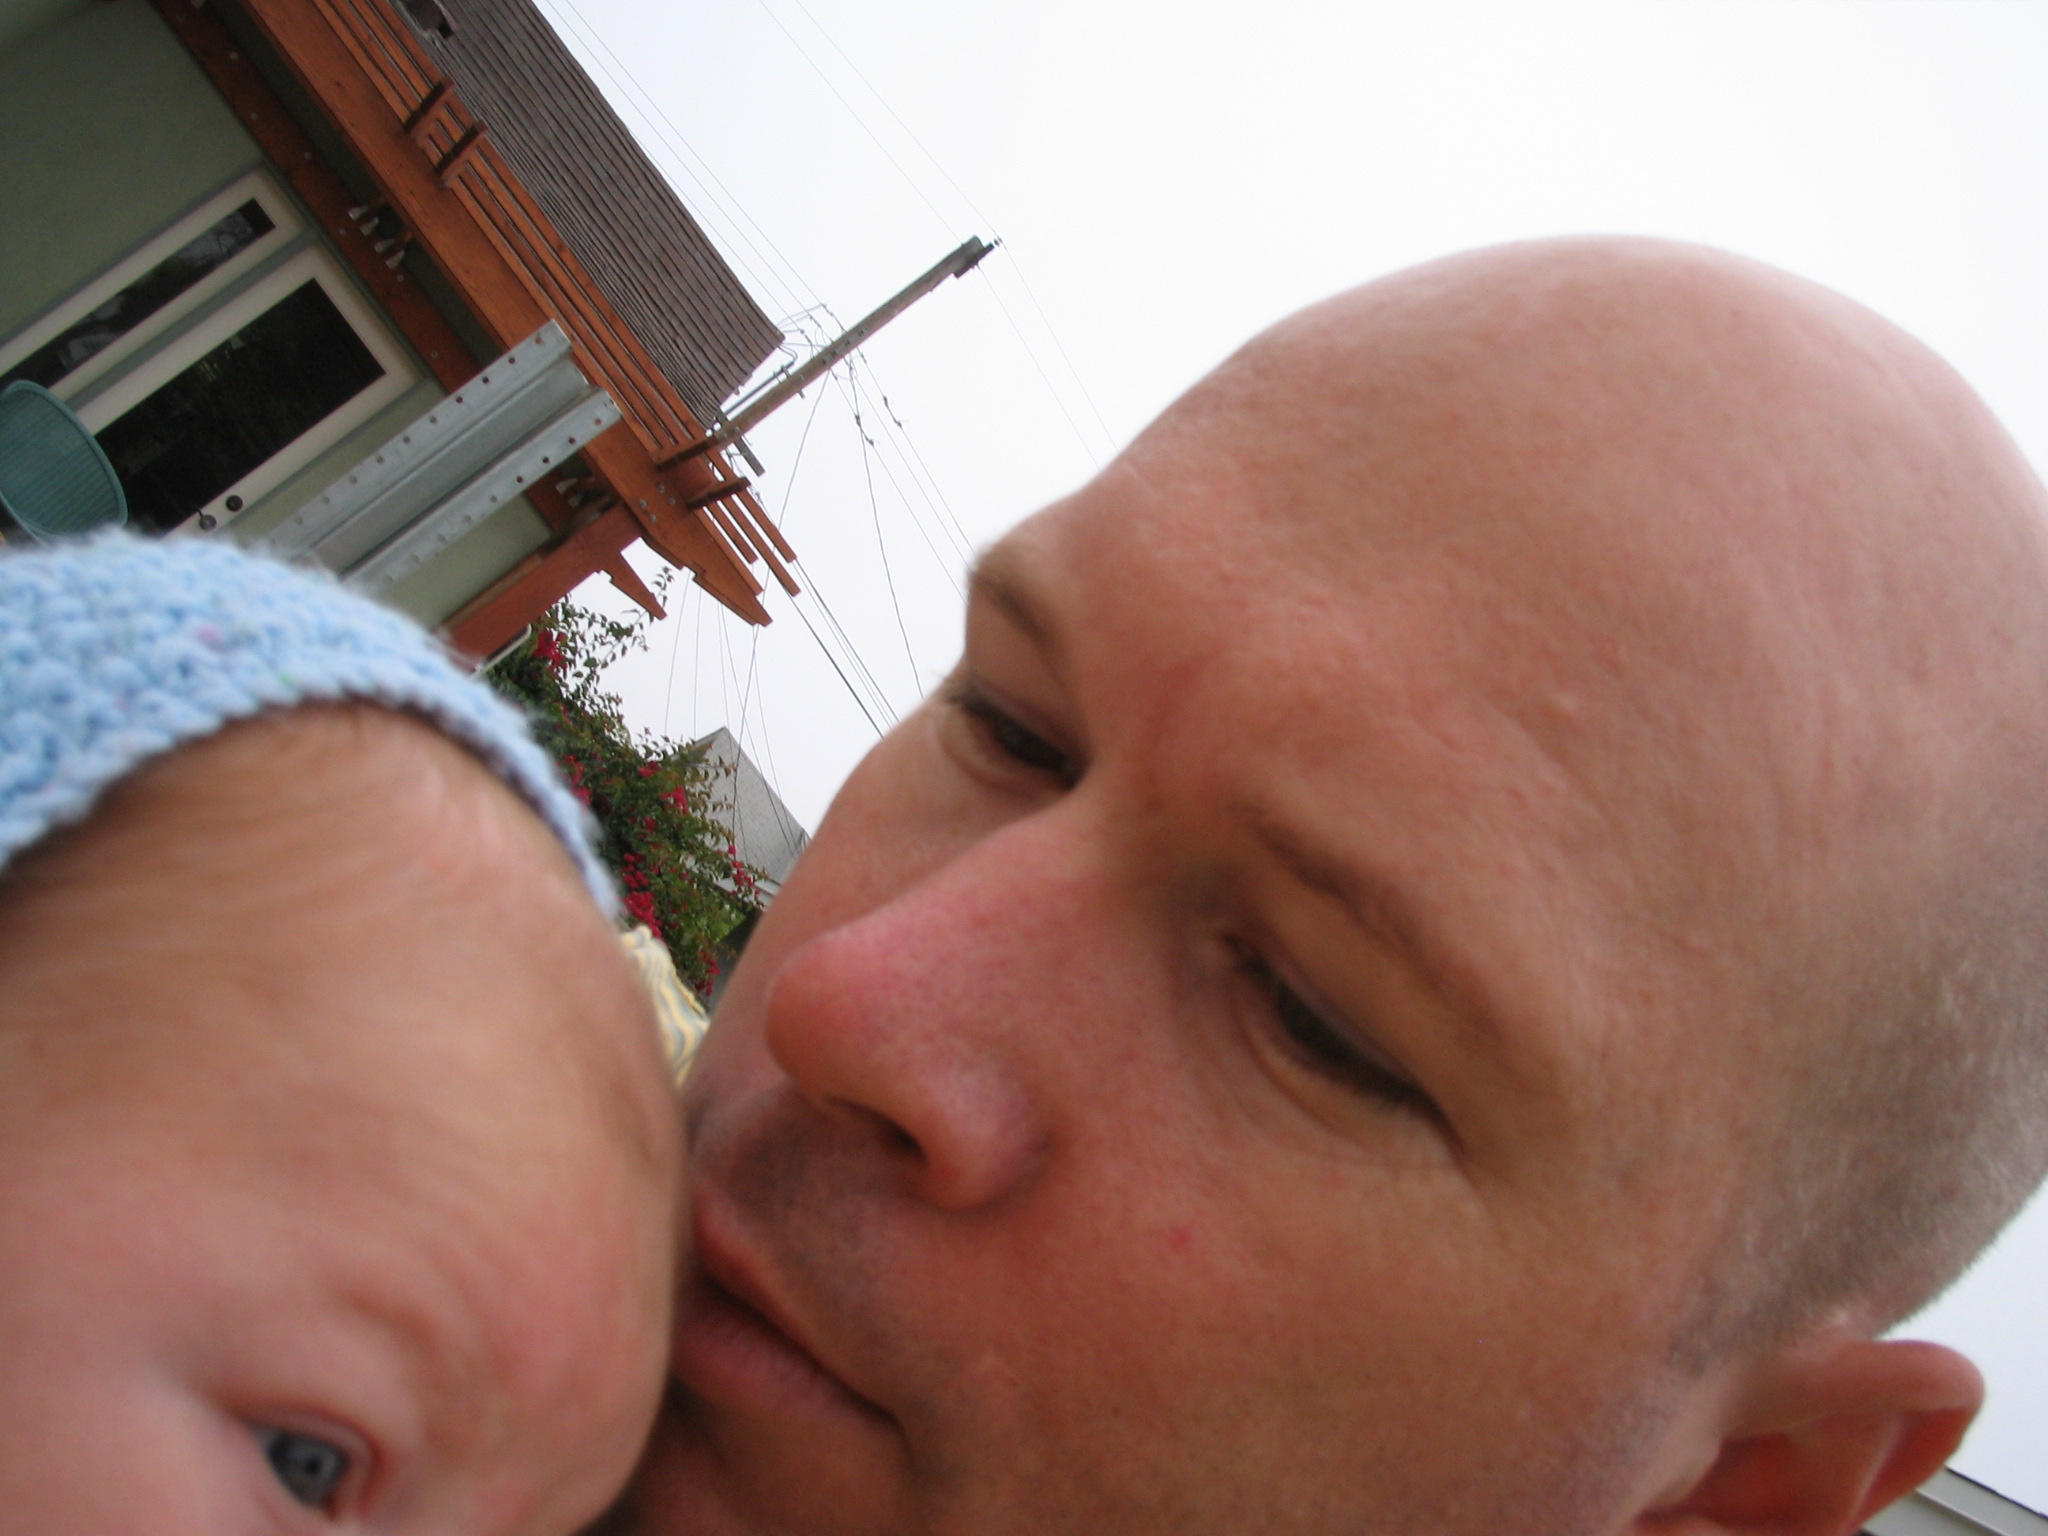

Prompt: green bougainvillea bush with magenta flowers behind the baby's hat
xmin=485 ymin=602 xmax=760 ymax=991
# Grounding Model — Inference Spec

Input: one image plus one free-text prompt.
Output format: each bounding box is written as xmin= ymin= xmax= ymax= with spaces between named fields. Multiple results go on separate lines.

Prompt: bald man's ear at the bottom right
xmin=1628 ymin=1325 xmax=1985 ymax=1536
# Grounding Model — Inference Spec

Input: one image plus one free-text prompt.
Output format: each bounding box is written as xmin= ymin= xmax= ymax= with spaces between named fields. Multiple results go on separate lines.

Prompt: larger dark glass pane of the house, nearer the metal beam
xmin=98 ymin=281 xmax=383 ymax=530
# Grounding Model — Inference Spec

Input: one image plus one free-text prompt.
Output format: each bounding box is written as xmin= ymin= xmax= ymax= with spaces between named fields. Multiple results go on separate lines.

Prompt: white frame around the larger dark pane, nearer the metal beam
xmin=76 ymin=246 xmax=420 ymax=528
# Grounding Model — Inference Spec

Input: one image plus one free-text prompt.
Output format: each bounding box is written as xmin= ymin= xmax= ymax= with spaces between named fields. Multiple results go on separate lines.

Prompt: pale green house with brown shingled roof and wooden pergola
xmin=0 ymin=0 xmax=795 ymax=655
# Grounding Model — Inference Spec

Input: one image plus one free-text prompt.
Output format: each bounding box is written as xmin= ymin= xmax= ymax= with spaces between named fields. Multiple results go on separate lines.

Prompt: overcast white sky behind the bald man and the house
xmin=541 ymin=0 xmax=2048 ymax=1509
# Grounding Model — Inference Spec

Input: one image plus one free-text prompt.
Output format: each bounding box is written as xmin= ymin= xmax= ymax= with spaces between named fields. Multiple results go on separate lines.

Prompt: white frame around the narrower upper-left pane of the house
xmin=0 ymin=170 xmax=305 ymax=401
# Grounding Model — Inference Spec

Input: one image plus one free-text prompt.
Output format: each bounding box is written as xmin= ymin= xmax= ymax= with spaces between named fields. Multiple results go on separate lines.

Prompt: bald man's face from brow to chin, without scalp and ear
xmin=639 ymin=387 xmax=1794 ymax=1536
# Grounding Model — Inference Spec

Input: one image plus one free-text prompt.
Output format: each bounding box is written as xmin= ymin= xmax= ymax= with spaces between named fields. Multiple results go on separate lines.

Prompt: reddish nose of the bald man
xmin=766 ymin=813 xmax=1106 ymax=1210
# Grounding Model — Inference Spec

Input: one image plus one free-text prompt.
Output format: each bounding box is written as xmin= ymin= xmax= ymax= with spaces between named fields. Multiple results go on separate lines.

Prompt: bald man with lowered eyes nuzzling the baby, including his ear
xmin=618 ymin=242 xmax=2048 ymax=1536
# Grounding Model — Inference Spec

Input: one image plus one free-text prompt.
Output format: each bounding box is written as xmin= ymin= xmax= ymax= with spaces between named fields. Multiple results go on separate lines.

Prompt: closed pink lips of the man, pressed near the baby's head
xmin=670 ymin=1206 xmax=889 ymax=1423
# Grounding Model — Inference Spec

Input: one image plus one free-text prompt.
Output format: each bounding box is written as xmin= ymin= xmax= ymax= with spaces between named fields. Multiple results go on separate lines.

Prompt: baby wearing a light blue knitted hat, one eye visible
xmin=0 ymin=541 xmax=680 ymax=1536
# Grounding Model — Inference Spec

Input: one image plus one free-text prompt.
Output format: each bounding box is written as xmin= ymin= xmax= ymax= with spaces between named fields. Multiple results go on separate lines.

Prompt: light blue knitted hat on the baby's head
xmin=0 ymin=535 xmax=616 ymax=915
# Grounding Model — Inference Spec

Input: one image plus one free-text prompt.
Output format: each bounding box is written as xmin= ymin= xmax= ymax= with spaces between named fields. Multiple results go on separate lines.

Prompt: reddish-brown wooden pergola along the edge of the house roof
xmin=154 ymin=0 xmax=797 ymax=655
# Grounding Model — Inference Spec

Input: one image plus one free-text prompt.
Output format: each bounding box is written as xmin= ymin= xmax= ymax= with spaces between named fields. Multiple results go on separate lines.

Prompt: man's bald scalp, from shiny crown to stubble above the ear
xmin=1130 ymin=240 xmax=2048 ymax=1358
